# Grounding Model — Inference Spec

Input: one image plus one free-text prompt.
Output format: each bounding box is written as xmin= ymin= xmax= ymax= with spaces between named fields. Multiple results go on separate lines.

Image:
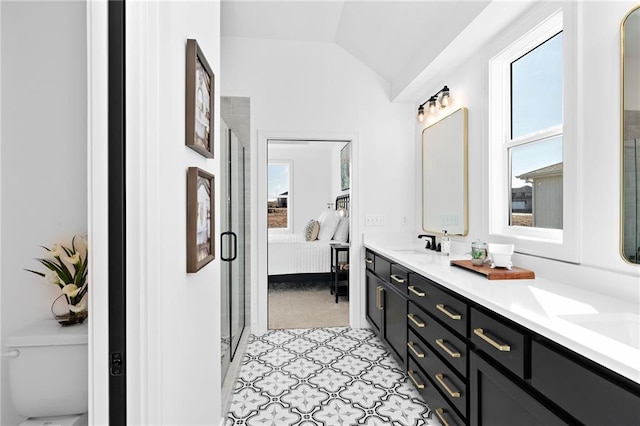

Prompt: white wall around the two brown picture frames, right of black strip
xmin=127 ymin=1 xmax=222 ymax=425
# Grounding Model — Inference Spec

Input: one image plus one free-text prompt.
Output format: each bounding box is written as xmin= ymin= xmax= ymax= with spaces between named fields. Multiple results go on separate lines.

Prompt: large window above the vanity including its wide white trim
xmin=488 ymin=8 xmax=578 ymax=262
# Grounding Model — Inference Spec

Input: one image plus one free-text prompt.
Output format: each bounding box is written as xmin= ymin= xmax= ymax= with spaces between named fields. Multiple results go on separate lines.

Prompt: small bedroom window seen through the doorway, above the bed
xmin=267 ymin=162 xmax=291 ymax=230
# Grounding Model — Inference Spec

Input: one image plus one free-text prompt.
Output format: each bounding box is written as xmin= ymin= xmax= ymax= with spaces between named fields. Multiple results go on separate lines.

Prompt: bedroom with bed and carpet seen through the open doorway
xmin=267 ymin=140 xmax=351 ymax=330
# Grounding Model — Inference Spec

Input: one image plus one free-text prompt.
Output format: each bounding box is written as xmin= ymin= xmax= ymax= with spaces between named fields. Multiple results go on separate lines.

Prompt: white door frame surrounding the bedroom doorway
xmin=251 ymin=130 xmax=365 ymax=334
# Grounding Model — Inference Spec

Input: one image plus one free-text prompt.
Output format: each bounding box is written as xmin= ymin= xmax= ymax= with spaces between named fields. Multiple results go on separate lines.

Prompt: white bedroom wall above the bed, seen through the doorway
xmin=268 ymin=142 xmax=335 ymax=234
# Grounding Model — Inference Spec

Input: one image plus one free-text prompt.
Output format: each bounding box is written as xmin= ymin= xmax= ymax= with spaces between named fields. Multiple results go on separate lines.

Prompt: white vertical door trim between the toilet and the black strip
xmin=87 ymin=1 xmax=109 ymax=425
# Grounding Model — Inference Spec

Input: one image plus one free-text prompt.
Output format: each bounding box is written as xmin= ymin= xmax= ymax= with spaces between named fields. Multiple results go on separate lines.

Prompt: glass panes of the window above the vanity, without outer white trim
xmin=505 ymin=32 xmax=563 ymax=229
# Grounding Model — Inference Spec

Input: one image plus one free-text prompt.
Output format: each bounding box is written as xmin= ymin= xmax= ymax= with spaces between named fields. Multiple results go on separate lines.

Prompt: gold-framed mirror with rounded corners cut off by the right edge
xmin=620 ymin=6 xmax=640 ymax=264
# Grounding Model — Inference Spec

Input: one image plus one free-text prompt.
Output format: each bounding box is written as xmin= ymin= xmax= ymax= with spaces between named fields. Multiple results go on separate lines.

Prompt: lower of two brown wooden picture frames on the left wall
xmin=187 ymin=167 xmax=215 ymax=273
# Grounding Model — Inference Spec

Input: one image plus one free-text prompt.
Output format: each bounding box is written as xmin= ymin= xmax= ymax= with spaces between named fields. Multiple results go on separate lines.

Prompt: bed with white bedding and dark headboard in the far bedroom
xmin=268 ymin=194 xmax=349 ymax=282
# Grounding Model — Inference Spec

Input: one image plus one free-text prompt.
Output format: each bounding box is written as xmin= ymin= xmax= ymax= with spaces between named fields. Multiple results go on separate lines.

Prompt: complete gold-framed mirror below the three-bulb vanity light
xmin=422 ymin=108 xmax=469 ymax=236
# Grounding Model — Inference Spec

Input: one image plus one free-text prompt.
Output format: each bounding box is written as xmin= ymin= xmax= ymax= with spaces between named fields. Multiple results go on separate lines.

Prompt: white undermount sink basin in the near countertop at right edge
xmin=559 ymin=312 xmax=640 ymax=349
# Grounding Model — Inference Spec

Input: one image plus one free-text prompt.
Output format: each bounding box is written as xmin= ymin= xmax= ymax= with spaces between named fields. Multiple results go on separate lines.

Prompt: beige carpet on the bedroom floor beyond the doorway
xmin=268 ymin=286 xmax=349 ymax=330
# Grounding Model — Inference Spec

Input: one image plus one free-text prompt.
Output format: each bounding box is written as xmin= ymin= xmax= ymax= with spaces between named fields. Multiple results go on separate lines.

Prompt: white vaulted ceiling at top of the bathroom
xmin=221 ymin=0 xmax=491 ymax=97
